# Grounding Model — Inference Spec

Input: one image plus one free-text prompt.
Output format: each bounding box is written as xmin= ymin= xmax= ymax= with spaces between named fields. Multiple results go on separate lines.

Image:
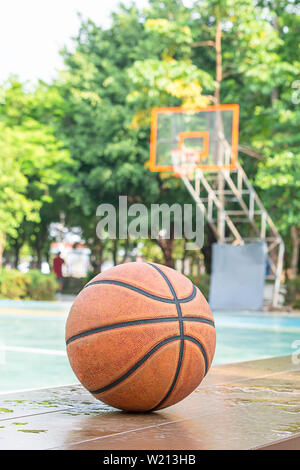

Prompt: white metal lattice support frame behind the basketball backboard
xmin=181 ymin=163 xmax=284 ymax=307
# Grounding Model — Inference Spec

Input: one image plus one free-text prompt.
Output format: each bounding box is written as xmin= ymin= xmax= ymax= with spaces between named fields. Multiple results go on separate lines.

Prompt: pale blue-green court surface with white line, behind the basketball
xmin=0 ymin=302 xmax=300 ymax=393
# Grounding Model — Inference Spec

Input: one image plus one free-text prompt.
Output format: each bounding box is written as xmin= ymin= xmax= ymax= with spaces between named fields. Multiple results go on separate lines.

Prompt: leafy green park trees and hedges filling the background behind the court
xmin=0 ymin=0 xmax=300 ymax=309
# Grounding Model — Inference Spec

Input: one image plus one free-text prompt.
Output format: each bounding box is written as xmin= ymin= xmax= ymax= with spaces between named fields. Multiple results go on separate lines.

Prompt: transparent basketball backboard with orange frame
xmin=149 ymin=104 xmax=239 ymax=172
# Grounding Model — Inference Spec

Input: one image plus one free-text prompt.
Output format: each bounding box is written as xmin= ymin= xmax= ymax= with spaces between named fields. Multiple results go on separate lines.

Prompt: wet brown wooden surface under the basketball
xmin=0 ymin=356 xmax=300 ymax=450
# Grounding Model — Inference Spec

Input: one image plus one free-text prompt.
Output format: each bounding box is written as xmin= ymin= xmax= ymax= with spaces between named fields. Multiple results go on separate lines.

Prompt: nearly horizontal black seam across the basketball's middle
xmin=66 ymin=316 xmax=215 ymax=345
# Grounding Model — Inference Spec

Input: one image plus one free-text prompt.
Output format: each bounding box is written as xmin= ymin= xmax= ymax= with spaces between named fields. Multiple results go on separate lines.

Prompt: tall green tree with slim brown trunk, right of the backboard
xmin=191 ymin=0 xmax=300 ymax=277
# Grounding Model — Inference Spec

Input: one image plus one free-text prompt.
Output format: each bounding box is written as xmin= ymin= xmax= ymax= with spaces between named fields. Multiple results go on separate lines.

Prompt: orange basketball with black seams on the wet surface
xmin=66 ymin=262 xmax=216 ymax=411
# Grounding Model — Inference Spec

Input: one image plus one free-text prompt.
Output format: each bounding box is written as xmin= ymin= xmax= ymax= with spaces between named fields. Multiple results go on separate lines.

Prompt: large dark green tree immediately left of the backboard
xmin=57 ymin=2 xmax=209 ymax=265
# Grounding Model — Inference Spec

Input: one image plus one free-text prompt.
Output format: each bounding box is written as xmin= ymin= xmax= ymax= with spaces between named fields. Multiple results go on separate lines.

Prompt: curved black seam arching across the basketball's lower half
xmin=89 ymin=335 xmax=208 ymax=396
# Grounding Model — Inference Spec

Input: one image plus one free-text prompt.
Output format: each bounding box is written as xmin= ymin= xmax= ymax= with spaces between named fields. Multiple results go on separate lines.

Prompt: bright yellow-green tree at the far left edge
xmin=0 ymin=79 xmax=70 ymax=264
